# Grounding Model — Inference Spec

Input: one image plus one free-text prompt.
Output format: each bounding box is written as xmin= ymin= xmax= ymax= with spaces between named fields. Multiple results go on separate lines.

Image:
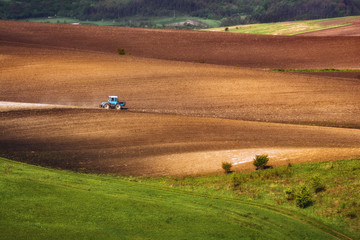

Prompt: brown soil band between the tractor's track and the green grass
xmin=0 ymin=109 xmax=360 ymax=175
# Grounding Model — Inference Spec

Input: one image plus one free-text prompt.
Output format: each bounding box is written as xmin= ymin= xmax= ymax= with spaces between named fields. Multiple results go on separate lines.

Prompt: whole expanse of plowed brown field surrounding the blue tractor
xmin=0 ymin=21 xmax=360 ymax=175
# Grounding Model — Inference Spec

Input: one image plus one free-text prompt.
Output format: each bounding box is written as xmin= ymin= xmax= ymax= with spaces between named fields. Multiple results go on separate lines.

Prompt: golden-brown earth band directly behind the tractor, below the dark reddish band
xmin=0 ymin=43 xmax=360 ymax=128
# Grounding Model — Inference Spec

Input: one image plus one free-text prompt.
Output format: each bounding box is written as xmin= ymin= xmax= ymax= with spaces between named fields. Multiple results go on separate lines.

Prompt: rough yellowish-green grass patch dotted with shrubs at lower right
xmin=145 ymin=159 xmax=360 ymax=239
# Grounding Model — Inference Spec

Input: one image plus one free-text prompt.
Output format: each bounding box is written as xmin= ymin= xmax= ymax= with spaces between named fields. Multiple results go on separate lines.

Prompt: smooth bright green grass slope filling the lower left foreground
xmin=0 ymin=158 xmax=354 ymax=239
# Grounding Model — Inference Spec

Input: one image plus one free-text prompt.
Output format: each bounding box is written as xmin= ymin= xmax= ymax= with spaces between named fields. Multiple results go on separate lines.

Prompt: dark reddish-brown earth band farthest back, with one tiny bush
xmin=0 ymin=21 xmax=360 ymax=68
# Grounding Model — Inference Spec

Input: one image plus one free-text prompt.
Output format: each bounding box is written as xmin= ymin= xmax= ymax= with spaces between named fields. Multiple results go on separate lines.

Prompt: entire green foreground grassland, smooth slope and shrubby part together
xmin=0 ymin=158 xmax=360 ymax=239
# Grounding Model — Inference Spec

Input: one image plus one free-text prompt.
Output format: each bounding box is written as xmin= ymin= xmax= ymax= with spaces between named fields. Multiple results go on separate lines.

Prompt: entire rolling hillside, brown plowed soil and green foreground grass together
xmin=0 ymin=15 xmax=360 ymax=239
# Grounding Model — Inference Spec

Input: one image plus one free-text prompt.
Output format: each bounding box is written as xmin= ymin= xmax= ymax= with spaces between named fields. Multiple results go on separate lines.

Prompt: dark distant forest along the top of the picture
xmin=0 ymin=0 xmax=360 ymax=26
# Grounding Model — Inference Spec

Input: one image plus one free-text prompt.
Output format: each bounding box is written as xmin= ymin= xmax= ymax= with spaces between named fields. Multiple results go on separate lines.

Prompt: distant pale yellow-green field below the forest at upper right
xmin=206 ymin=17 xmax=349 ymax=36
